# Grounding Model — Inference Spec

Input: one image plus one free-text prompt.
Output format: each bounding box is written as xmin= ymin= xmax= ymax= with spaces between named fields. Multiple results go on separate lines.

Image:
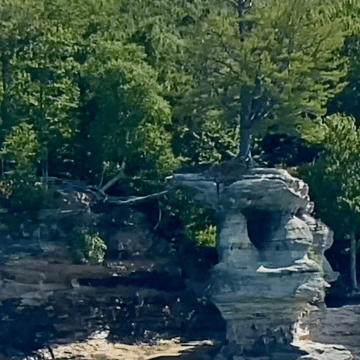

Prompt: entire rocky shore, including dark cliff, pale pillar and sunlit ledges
xmin=0 ymin=170 xmax=360 ymax=360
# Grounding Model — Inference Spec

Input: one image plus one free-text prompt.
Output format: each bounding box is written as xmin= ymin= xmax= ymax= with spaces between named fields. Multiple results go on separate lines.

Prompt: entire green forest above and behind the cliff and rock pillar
xmin=0 ymin=0 xmax=360 ymax=288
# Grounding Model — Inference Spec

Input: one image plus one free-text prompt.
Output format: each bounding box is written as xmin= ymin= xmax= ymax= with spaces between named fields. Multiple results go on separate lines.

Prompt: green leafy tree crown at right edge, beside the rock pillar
xmin=300 ymin=114 xmax=360 ymax=235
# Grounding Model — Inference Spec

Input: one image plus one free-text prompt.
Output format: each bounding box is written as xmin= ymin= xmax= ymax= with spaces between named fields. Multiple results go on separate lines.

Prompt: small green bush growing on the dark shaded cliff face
xmin=68 ymin=228 xmax=106 ymax=264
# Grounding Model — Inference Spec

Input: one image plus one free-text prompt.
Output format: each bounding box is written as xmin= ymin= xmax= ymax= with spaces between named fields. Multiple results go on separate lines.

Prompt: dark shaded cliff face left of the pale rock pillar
xmin=0 ymin=192 xmax=225 ymax=360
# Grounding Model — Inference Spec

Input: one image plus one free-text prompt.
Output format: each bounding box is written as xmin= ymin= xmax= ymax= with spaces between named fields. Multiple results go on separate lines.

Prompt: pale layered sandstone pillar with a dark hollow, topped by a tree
xmin=169 ymin=168 xmax=340 ymax=360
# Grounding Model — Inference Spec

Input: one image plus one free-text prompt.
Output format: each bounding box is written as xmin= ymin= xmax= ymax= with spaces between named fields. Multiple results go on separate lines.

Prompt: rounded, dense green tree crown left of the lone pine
xmin=86 ymin=40 xmax=178 ymax=174
